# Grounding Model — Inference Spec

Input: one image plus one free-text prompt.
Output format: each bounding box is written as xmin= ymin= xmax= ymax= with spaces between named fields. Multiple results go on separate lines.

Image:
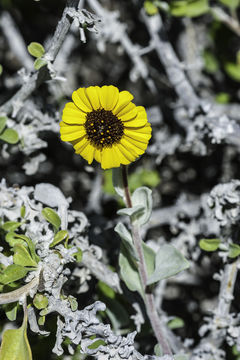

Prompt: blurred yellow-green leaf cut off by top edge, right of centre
xmin=170 ymin=0 xmax=209 ymax=17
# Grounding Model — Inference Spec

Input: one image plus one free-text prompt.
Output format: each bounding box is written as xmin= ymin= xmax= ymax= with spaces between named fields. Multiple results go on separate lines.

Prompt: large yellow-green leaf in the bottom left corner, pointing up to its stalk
xmin=0 ymin=318 xmax=32 ymax=360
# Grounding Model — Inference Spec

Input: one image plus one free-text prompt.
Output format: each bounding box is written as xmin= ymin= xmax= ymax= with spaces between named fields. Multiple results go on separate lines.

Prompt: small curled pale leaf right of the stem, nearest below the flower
xmin=132 ymin=186 xmax=152 ymax=225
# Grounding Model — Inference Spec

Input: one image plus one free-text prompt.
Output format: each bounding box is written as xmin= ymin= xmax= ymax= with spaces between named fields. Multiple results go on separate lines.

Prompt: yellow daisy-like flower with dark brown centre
xmin=60 ymin=85 xmax=152 ymax=169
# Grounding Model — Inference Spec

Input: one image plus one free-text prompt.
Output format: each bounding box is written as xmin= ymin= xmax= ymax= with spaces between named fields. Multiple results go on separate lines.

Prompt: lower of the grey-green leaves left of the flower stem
xmin=119 ymin=245 xmax=144 ymax=297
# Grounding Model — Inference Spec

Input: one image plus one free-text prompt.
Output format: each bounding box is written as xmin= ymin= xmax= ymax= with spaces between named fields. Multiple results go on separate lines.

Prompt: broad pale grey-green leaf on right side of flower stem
xmin=147 ymin=244 xmax=189 ymax=285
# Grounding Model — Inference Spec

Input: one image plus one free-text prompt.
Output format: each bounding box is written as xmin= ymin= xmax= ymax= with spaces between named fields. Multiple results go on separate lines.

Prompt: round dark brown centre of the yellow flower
xmin=84 ymin=109 xmax=124 ymax=150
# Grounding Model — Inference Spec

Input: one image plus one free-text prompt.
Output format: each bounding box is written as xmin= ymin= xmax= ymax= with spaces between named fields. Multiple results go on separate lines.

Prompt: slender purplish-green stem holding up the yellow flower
xmin=122 ymin=165 xmax=172 ymax=355
